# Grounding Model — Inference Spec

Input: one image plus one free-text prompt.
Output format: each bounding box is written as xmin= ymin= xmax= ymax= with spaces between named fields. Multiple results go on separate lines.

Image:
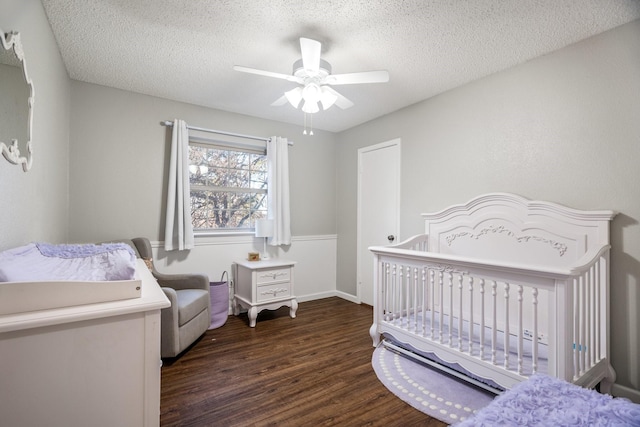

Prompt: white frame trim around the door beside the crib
xmin=356 ymin=138 xmax=402 ymax=304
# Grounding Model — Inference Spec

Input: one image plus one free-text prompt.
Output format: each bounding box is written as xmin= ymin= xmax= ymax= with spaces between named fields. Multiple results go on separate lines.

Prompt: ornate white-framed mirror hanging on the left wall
xmin=0 ymin=29 xmax=34 ymax=172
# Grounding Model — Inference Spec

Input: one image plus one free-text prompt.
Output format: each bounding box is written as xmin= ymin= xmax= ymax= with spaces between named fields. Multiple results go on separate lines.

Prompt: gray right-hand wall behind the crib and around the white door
xmin=336 ymin=21 xmax=640 ymax=390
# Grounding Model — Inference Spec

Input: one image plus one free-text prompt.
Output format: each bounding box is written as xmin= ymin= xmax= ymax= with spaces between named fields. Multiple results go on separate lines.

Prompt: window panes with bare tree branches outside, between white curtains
xmin=189 ymin=141 xmax=267 ymax=231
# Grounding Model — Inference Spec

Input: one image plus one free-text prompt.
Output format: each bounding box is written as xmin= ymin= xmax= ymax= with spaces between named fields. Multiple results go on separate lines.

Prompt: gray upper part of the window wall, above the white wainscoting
xmin=69 ymin=81 xmax=336 ymax=242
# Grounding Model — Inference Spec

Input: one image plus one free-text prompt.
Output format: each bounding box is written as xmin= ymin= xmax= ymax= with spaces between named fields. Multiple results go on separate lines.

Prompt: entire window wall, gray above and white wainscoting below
xmin=69 ymin=81 xmax=336 ymax=300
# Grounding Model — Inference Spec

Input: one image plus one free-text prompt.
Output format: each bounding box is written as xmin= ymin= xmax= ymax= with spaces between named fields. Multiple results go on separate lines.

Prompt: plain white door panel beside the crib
xmin=357 ymin=139 xmax=400 ymax=305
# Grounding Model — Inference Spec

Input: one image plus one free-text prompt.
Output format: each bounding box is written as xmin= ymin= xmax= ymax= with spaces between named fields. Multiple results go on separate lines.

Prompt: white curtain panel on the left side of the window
xmin=164 ymin=120 xmax=194 ymax=251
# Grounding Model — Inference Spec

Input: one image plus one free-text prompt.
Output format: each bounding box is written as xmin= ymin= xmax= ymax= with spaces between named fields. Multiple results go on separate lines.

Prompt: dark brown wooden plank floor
xmin=160 ymin=298 xmax=446 ymax=427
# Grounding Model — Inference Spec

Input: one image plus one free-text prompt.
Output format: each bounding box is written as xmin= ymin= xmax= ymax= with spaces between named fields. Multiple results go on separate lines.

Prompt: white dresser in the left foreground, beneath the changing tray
xmin=0 ymin=260 xmax=170 ymax=427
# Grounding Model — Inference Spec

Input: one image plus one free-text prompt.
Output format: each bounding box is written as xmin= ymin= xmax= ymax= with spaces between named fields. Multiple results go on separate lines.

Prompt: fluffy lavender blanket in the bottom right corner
xmin=456 ymin=374 xmax=640 ymax=427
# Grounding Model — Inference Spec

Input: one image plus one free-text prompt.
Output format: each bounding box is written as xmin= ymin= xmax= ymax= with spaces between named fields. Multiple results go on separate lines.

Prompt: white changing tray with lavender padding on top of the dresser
xmin=0 ymin=243 xmax=144 ymax=315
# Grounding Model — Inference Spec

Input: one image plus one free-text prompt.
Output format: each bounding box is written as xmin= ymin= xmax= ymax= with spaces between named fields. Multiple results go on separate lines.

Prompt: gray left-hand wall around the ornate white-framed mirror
xmin=0 ymin=0 xmax=70 ymax=250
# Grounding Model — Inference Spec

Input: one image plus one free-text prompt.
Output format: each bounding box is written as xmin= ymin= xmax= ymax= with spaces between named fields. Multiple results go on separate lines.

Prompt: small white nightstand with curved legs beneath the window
xmin=233 ymin=259 xmax=298 ymax=328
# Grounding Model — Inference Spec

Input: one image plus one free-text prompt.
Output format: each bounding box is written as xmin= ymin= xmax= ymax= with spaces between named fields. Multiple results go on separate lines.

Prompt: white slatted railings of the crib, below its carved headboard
xmin=371 ymin=236 xmax=609 ymax=388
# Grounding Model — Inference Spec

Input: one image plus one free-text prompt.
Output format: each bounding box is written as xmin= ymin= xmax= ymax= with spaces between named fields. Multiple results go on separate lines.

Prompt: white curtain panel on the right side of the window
xmin=267 ymin=136 xmax=291 ymax=246
